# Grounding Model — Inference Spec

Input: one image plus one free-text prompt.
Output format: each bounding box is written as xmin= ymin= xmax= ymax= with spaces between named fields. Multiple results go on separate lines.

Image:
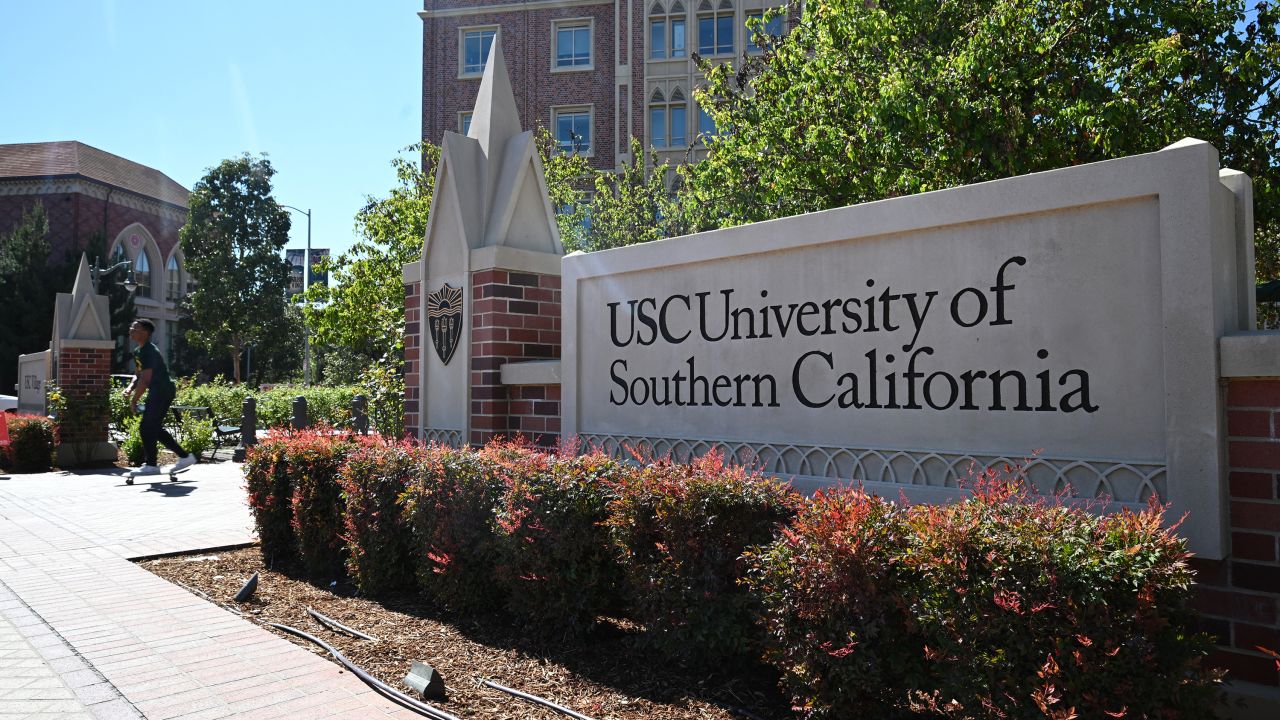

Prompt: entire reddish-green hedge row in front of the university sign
xmin=246 ymin=433 xmax=1217 ymax=719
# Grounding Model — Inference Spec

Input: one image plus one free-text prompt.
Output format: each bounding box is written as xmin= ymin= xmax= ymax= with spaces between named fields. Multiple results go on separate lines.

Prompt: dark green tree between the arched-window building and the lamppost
xmin=178 ymin=154 xmax=289 ymax=382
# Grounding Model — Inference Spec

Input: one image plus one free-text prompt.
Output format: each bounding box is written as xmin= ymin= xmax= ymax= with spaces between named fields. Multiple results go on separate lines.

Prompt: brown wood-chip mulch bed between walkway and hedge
xmin=141 ymin=547 xmax=790 ymax=720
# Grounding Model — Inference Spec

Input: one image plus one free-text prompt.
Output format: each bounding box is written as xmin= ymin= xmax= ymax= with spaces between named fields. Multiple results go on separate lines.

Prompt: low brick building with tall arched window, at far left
xmin=0 ymin=141 xmax=188 ymax=356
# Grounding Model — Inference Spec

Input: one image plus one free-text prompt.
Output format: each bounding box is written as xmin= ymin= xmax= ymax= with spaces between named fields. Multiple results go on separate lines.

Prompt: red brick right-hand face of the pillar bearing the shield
xmin=470 ymin=268 xmax=561 ymax=445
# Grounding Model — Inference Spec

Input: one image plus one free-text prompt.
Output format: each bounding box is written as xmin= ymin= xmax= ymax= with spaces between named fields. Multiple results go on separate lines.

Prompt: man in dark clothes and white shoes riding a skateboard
xmin=124 ymin=319 xmax=196 ymax=480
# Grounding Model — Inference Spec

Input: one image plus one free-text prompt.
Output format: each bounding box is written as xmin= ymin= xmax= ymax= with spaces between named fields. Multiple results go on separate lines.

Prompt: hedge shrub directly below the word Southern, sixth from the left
xmin=609 ymin=452 xmax=797 ymax=665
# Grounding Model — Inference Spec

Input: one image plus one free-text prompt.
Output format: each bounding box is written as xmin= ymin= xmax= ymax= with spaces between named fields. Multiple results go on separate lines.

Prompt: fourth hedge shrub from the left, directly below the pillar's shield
xmin=404 ymin=447 xmax=506 ymax=612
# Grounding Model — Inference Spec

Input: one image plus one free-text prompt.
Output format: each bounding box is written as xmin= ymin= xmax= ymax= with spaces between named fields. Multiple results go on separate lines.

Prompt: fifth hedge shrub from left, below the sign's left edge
xmin=485 ymin=445 xmax=632 ymax=635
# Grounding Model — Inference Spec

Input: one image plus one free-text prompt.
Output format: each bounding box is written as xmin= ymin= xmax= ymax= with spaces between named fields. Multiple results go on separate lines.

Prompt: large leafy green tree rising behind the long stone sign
xmin=681 ymin=0 xmax=1280 ymax=289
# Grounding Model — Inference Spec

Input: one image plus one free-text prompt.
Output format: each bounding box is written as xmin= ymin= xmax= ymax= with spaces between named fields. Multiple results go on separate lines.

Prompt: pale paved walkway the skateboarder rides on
xmin=0 ymin=462 xmax=419 ymax=720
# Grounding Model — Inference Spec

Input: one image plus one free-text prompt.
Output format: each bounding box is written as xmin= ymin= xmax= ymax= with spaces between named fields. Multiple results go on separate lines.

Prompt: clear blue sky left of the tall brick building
xmin=0 ymin=0 xmax=422 ymax=252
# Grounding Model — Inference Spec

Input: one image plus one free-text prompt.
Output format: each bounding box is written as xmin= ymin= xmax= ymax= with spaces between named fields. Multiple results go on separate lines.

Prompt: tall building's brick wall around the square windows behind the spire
xmin=422 ymin=0 xmax=619 ymax=169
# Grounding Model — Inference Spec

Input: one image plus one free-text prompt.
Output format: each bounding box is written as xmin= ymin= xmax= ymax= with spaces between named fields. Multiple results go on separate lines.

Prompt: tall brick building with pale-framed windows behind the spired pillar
xmin=419 ymin=0 xmax=786 ymax=169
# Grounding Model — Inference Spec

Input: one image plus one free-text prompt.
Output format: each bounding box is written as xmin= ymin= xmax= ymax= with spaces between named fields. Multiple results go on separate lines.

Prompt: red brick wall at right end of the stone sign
xmin=1193 ymin=378 xmax=1280 ymax=687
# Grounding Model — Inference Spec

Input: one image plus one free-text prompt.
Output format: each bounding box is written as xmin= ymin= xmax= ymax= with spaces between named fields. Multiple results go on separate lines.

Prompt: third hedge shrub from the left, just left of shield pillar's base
xmin=338 ymin=443 xmax=431 ymax=594
